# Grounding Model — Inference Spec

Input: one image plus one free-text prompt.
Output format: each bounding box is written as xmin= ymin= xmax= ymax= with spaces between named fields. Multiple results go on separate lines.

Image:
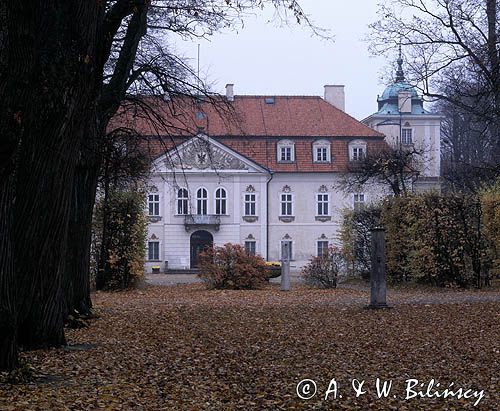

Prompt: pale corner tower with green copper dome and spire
xmin=362 ymin=48 xmax=442 ymax=191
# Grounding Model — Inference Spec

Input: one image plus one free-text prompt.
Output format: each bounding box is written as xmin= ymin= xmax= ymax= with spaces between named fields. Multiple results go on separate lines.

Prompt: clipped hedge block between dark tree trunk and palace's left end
xmin=93 ymin=191 xmax=147 ymax=290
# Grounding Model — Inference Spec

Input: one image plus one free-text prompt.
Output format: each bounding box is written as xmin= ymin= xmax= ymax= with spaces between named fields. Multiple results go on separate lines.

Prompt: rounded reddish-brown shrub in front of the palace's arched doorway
xmin=198 ymin=243 xmax=268 ymax=290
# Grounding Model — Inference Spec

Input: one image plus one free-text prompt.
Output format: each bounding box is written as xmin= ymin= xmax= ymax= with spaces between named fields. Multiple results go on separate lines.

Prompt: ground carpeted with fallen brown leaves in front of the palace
xmin=0 ymin=284 xmax=500 ymax=411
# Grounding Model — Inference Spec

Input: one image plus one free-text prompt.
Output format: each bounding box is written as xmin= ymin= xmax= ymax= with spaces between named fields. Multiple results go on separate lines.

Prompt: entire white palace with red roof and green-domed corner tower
xmin=118 ymin=63 xmax=440 ymax=272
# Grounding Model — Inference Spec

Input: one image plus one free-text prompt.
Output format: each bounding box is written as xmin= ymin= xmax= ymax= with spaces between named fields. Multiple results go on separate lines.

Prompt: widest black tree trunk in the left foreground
xmin=9 ymin=0 xmax=101 ymax=348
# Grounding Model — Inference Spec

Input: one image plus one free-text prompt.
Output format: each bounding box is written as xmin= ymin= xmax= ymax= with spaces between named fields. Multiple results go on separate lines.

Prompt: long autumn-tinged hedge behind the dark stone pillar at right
xmin=341 ymin=184 xmax=500 ymax=287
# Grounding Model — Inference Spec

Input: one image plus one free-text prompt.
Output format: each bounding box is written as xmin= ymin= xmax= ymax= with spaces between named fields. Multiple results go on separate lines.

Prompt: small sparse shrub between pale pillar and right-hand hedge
xmin=302 ymin=247 xmax=345 ymax=288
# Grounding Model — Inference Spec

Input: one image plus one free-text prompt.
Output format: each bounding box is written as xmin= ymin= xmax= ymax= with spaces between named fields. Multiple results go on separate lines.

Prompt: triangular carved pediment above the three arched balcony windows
xmin=154 ymin=134 xmax=267 ymax=173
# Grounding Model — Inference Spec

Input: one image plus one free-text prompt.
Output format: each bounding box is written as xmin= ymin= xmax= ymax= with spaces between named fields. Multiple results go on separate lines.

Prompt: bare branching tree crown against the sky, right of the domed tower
xmin=370 ymin=0 xmax=500 ymax=167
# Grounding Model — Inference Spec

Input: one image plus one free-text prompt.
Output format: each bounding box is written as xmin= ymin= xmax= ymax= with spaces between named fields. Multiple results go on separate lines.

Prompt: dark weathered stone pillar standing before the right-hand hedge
xmin=367 ymin=227 xmax=390 ymax=309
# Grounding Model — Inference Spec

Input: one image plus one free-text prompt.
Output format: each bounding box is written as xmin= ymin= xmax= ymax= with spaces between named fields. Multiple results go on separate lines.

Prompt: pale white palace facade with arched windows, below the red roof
xmin=146 ymin=135 xmax=382 ymax=272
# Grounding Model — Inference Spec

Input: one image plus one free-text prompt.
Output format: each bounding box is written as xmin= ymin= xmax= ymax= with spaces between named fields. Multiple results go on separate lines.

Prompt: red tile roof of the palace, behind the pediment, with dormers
xmin=111 ymin=96 xmax=385 ymax=172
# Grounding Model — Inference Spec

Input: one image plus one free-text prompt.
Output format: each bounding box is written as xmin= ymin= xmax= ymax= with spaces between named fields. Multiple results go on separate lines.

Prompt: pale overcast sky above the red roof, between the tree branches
xmin=175 ymin=0 xmax=390 ymax=120
